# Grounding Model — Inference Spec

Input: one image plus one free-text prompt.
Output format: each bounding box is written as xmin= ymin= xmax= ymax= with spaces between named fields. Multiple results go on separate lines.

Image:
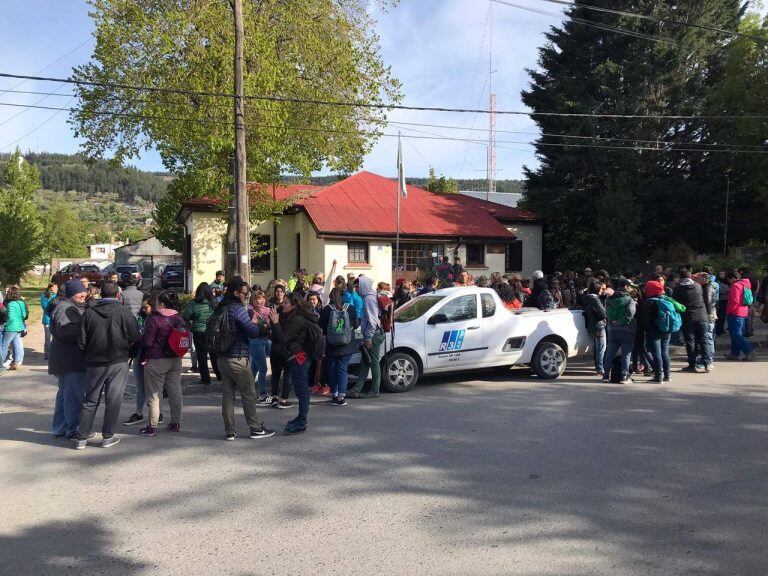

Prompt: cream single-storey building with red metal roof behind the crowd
xmin=178 ymin=172 xmax=542 ymax=290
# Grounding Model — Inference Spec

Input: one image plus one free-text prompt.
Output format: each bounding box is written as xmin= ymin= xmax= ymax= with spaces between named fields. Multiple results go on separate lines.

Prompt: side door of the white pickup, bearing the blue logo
xmin=425 ymin=294 xmax=485 ymax=371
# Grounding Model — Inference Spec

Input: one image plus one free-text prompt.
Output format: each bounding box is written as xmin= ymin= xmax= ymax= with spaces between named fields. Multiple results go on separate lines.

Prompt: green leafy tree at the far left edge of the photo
xmin=0 ymin=148 xmax=44 ymax=282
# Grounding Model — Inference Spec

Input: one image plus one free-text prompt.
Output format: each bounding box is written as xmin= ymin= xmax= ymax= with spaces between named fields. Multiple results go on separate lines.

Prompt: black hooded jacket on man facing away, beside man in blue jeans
xmin=77 ymin=298 xmax=141 ymax=366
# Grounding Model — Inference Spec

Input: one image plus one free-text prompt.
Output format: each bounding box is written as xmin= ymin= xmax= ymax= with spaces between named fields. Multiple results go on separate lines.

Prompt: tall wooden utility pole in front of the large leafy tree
xmin=232 ymin=0 xmax=251 ymax=285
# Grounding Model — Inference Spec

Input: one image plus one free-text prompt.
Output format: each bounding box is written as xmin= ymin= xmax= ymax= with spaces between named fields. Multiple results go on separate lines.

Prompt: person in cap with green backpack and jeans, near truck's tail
xmin=603 ymin=277 xmax=637 ymax=384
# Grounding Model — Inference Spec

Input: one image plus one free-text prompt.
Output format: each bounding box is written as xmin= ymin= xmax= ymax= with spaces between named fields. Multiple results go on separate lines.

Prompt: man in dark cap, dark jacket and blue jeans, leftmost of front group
xmin=48 ymin=278 xmax=87 ymax=438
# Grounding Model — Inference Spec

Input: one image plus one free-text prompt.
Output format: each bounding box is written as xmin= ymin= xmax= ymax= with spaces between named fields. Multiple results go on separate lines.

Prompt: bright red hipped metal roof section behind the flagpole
xmin=297 ymin=171 xmax=538 ymax=238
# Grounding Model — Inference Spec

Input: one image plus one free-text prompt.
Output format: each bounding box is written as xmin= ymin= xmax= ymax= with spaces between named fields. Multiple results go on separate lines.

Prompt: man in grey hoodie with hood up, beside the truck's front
xmin=347 ymin=275 xmax=384 ymax=398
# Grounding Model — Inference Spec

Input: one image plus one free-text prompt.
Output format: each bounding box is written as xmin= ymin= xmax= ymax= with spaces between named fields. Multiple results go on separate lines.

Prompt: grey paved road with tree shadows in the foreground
xmin=0 ymin=326 xmax=768 ymax=576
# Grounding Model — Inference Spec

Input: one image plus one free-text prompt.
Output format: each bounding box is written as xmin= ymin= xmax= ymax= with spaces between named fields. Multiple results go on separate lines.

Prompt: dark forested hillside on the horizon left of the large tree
xmin=0 ymin=152 xmax=168 ymax=204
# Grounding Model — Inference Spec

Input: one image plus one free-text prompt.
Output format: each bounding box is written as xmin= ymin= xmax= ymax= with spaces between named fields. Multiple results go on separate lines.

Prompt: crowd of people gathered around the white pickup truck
xmin=0 ymin=257 xmax=768 ymax=449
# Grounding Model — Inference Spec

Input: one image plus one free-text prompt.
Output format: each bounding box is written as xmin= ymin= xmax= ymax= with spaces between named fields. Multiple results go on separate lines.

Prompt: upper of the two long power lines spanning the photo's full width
xmin=0 ymin=72 xmax=768 ymax=120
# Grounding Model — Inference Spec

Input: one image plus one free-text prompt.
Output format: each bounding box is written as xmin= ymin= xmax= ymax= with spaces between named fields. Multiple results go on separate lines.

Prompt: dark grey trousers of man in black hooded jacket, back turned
xmin=79 ymin=362 xmax=128 ymax=438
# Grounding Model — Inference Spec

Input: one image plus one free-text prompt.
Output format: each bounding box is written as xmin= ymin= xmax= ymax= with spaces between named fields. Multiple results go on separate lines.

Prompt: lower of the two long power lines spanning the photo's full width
xmin=0 ymin=102 xmax=768 ymax=154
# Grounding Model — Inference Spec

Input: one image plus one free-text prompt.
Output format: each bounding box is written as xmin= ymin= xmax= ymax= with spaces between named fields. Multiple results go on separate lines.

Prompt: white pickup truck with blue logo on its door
xmin=381 ymin=287 xmax=591 ymax=392
